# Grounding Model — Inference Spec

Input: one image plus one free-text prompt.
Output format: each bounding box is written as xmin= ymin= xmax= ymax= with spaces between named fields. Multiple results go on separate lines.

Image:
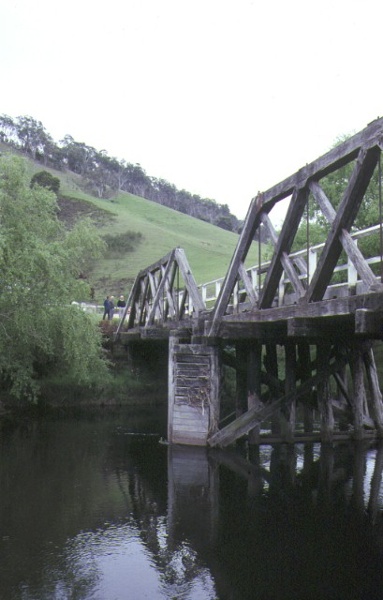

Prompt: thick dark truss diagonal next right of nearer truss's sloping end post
xmin=259 ymin=186 xmax=309 ymax=308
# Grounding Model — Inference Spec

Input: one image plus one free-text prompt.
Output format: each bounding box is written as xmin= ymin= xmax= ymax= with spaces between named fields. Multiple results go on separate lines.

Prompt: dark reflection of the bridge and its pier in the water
xmin=167 ymin=442 xmax=383 ymax=600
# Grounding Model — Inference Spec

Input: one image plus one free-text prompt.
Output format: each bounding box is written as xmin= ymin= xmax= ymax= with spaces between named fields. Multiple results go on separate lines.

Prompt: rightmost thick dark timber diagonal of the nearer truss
xmin=305 ymin=146 xmax=380 ymax=302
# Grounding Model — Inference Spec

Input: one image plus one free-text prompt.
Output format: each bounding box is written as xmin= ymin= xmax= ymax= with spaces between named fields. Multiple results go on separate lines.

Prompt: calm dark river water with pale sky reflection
xmin=0 ymin=413 xmax=383 ymax=600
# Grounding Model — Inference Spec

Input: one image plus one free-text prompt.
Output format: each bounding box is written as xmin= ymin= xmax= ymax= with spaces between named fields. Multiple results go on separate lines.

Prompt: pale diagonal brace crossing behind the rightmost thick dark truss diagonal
xmin=310 ymin=181 xmax=376 ymax=287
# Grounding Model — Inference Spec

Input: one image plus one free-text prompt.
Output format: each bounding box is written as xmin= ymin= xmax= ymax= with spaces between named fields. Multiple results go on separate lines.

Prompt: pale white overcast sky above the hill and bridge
xmin=0 ymin=0 xmax=383 ymax=218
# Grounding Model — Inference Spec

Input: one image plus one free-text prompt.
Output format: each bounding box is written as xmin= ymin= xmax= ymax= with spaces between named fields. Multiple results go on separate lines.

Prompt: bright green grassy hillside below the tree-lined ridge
xmin=0 ymin=144 xmax=258 ymax=301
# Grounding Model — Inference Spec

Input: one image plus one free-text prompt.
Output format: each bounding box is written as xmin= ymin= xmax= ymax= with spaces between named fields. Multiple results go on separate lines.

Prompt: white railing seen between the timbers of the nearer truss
xmin=198 ymin=225 xmax=382 ymax=312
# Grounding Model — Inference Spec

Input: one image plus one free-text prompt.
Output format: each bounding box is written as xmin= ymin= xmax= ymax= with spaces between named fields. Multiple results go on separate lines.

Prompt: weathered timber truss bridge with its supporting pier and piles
xmin=116 ymin=118 xmax=383 ymax=447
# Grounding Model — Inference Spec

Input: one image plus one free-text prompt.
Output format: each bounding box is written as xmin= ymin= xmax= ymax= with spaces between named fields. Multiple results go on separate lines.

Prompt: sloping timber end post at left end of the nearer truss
xmin=208 ymin=193 xmax=273 ymax=337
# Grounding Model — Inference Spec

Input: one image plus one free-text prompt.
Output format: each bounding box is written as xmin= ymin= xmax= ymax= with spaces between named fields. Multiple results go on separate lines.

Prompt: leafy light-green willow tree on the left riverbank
xmin=0 ymin=156 xmax=108 ymax=400
